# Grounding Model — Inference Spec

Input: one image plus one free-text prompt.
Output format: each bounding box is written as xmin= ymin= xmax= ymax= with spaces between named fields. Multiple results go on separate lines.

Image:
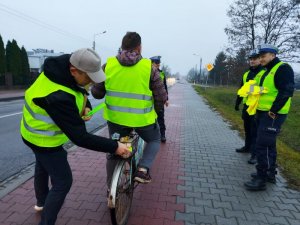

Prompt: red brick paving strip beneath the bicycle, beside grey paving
xmin=0 ymin=86 xmax=184 ymax=225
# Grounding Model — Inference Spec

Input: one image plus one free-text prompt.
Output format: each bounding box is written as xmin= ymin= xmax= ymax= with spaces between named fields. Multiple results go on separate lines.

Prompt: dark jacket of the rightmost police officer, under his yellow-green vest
xmin=259 ymin=57 xmax=295 ymax=113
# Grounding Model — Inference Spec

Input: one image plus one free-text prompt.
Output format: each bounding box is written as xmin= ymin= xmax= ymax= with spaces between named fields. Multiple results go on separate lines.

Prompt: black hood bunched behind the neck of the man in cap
xmin=44 ymin=54 xmax=86 ymax=94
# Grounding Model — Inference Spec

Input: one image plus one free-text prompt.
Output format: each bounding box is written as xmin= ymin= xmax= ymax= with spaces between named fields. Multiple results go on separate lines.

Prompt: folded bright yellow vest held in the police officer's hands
xmin=238 ymin=80 xmax=268 ymax=115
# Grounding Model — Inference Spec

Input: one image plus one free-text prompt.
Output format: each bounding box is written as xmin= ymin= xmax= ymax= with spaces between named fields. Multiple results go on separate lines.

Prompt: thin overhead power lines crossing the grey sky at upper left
xmin=0 ymin=3 xmax=90 ymax=42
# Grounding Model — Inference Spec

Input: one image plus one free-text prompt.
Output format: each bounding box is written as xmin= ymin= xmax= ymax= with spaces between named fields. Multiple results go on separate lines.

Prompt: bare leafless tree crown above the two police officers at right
xmin=225 ymin=0 xmax=300 ymax=59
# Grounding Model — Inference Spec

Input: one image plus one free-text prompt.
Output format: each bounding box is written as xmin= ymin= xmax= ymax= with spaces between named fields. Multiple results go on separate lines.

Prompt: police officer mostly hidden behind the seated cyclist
xmin=150 ymin=56 xmax=169 ymax=142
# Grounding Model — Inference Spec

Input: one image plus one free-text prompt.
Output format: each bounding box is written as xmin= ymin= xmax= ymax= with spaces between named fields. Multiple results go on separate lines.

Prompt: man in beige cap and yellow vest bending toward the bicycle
xmin=21 ymin=48 xmax=131 ymax=225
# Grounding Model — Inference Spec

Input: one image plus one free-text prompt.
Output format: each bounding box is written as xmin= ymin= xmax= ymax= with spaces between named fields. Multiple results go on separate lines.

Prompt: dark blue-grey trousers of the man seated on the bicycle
xmin=106 ymin=121 xmax=160 ymax=188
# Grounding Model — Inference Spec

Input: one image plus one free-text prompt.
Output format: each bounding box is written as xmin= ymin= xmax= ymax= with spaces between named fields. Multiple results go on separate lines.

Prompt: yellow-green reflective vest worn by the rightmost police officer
xmin=257 ymin=62 xmax=291 ymax=114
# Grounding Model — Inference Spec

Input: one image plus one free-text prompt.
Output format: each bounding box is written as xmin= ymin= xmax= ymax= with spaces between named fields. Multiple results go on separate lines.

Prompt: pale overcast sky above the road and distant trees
xmin=0 ymin=0 xmax=300 ymax=75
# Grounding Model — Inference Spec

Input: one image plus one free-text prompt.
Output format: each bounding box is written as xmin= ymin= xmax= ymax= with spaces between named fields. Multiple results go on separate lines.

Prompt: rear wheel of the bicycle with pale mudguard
xmin=109 ymin=160 xmax=133 ymax=225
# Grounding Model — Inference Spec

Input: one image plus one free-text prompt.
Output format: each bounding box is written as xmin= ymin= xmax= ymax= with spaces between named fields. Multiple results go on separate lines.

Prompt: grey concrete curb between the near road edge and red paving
xmin=0 ymin=125 xmax=106 ymax=199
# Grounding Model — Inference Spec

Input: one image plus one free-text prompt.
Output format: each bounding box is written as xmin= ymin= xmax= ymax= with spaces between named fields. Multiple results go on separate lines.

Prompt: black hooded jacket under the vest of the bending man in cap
xmin=25 ymin=54 xmax=118 ymax=153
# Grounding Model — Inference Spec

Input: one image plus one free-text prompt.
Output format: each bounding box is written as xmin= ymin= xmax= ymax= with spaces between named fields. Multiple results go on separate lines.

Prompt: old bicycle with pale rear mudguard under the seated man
xmin=108 ymin=130 xmax=145 ymax=225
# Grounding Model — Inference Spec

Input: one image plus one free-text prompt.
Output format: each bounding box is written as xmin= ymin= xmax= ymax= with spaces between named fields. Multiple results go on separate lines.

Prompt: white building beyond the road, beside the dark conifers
xmin=27 ymin=48 xmax=64 ymax=73
